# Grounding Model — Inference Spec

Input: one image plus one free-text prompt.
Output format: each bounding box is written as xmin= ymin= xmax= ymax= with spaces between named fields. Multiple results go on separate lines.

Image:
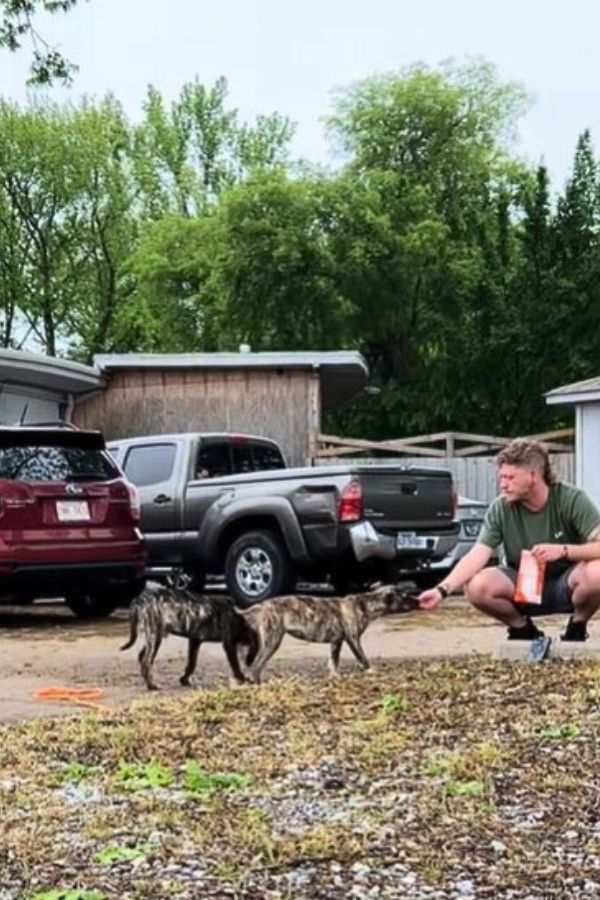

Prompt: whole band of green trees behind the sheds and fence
xmin=0 ymin=61 xmax=600 ymax=438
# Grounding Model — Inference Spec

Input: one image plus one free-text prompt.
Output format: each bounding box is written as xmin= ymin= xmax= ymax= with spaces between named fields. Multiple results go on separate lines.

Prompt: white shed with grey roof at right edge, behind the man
xmin=545 ymin=378 xmax=600 ymax=508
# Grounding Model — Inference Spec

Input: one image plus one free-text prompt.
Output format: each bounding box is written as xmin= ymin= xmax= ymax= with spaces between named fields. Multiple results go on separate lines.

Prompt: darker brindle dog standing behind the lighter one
xmin=121 ymin=583 xmax=257 ymax=691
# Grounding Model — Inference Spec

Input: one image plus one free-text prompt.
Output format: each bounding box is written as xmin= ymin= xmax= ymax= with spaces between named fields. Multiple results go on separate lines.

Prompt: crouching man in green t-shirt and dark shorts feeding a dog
xmin=419 ymin=439 xmax=600 ymax=641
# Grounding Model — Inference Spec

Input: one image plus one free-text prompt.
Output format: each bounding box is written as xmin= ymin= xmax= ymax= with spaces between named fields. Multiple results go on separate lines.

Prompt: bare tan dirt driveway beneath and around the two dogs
xmin=0 ymin=600 xmax=600 ymax=722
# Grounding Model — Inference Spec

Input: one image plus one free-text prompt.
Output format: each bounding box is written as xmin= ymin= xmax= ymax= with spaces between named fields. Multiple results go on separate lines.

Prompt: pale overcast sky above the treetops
xmin=0 ymin=0 xmax=600 ymax=190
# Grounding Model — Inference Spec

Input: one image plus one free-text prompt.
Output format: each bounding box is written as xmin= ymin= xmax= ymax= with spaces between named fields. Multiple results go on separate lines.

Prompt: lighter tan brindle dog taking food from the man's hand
xmin=238 ymin=585 xmax=418 ymax=684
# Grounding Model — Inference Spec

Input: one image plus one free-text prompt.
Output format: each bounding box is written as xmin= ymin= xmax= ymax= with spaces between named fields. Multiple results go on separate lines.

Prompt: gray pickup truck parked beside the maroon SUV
xmin=108 ymin=433 xmax=458 ymax=604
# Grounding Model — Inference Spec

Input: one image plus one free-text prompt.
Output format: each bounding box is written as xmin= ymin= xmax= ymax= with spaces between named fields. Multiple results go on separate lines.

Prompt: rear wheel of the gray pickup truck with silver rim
xmin=225 ymin=531 xmax=296 ymax=606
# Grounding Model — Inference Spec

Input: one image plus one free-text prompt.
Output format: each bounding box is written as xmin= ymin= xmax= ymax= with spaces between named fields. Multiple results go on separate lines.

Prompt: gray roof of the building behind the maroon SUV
xmin=0 ymin=350 xmax=105 ymax=394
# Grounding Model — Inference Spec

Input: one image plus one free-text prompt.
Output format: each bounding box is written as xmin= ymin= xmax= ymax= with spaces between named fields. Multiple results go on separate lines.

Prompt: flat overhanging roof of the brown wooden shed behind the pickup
xmin=94 ymin=350 xmax=369 ymax=406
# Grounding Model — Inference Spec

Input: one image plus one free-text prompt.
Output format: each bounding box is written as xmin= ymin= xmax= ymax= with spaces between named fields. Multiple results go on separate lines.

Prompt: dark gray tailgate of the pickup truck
xmin=357 ymin=466 xmax=455 ymax=531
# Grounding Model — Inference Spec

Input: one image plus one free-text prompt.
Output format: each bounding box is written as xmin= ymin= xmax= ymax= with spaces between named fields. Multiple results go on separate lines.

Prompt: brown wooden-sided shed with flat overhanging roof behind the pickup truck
xmin=73 ymin=350 xmax=368 ymax=465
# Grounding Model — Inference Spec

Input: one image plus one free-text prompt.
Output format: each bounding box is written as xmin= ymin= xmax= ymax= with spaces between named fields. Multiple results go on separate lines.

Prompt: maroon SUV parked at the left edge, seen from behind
xmin=0 ymin=426 xmax=146 ymax=617
